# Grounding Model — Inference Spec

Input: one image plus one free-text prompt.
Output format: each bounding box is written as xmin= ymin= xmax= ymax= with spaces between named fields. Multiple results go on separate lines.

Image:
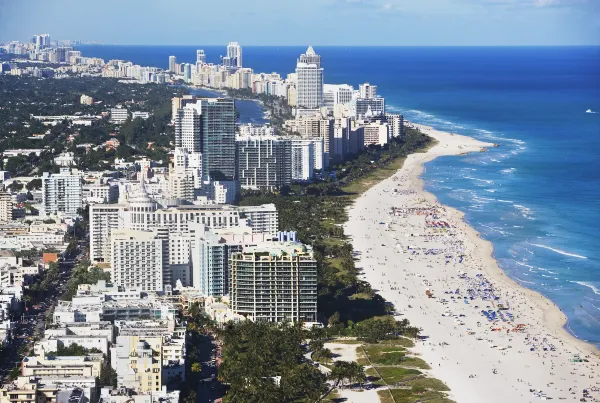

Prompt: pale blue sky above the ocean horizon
xmin=0 ymin=0 xmax=600 ymax=46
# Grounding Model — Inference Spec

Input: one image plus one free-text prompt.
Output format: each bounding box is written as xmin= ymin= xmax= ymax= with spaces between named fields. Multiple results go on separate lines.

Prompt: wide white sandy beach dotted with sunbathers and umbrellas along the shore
xmin=345 ymin=125 xmax=600 ymax=403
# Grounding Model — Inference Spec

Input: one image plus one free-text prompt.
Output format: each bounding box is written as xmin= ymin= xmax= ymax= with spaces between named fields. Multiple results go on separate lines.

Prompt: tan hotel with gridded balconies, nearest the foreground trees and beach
xmin=229 ymin=242 xmax=317 ymax=322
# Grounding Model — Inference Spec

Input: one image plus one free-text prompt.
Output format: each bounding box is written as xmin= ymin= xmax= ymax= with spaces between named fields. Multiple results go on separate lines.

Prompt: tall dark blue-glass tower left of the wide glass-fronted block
xmin=203 ymin=98 xmax=237 ymax=181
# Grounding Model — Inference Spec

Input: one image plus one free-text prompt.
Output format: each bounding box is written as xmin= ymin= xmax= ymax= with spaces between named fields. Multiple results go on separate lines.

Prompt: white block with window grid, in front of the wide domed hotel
xmin=111 ymin=229 xmax=168 ymax=291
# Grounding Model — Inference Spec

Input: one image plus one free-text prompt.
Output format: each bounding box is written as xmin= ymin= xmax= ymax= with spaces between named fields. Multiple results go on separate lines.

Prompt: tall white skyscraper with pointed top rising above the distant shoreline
xmin=296 ymin=46 xmax=323 ymax=109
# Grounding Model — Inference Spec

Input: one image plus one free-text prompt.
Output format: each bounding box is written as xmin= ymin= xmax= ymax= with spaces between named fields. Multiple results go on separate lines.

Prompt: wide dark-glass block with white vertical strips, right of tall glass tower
xmin=236 ymin=136 xmax=292 ymax=191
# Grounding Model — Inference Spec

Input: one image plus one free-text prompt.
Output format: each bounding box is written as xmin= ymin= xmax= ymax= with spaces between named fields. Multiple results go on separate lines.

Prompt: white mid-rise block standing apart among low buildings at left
xmin=42 ymin=168 xmax=83 ymax=216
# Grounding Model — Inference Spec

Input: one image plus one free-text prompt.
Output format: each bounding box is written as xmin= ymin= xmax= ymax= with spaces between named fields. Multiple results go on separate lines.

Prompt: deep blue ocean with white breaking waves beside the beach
xmin=78 ymin=46 xmax=600 ymax=345
